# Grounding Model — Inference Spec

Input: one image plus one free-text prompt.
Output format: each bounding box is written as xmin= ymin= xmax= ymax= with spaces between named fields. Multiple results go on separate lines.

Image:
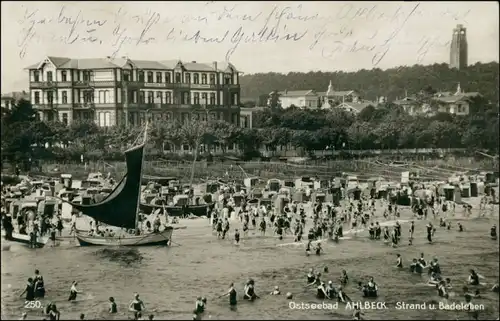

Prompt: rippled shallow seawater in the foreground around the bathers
xmin=1 ymin=200 xmax=499 ymax=320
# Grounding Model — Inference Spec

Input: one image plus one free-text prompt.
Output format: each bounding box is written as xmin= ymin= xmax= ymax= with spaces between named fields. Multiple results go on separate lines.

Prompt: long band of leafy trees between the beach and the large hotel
xmin=1 ymin=100 xmax=499 ymax=162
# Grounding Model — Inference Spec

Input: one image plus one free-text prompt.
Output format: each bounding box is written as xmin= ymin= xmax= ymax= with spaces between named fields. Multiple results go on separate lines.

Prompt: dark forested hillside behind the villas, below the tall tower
xmin=240 ymin=62 xmax=499 ymax=105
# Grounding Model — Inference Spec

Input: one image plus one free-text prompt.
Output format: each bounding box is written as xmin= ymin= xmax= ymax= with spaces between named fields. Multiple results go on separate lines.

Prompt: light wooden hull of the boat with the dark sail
xmin=76 ymin=227 xmax=174 ymax=246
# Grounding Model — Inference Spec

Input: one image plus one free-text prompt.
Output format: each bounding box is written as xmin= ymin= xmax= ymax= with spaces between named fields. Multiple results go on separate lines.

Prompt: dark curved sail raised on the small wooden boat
xmin=69 ymin=144 xmax=144 ymax=229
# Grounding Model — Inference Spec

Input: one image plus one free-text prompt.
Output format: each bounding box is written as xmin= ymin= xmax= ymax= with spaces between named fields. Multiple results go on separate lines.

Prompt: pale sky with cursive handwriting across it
xmin=1 ymin=1 xmax=499 ymax=93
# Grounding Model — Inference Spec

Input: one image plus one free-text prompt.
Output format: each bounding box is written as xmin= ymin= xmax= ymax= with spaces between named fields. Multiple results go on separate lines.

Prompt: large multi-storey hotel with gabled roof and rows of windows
xmin=26 ymin=57 xmax=241 ymax=127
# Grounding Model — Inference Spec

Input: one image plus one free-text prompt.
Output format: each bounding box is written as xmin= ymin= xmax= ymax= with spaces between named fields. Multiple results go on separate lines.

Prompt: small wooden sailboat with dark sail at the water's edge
xmin=62 ymin=117 xmax=174 ymax=246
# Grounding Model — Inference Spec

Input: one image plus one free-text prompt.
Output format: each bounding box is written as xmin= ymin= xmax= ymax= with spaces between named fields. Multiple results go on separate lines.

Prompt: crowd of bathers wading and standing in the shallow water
xmin=2 ymin=176 xmax=498 ymax=320
